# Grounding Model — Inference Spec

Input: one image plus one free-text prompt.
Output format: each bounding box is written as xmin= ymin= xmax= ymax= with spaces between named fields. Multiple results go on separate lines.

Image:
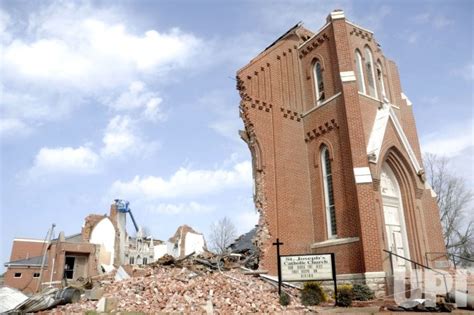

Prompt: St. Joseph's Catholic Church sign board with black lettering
xmin=280 ymin=254 xmax=335 ymax=281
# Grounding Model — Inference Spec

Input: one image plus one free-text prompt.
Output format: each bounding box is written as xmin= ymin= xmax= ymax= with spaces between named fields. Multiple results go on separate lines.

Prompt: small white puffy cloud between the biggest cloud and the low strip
xmin=100 ymin=115 xmax=157 ymax=158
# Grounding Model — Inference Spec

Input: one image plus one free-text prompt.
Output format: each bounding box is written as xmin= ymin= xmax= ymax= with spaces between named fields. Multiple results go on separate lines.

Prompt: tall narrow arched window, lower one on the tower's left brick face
xmin=321 ymin=146 xmax=337 ymax=238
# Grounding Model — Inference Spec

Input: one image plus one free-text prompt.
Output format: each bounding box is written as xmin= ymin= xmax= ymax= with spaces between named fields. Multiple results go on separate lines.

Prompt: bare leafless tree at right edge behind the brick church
xmin=424 ymin=154 xmax=474 ymax=264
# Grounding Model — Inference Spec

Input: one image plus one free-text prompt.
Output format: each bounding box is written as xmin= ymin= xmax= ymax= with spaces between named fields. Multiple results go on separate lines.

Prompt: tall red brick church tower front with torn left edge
xmin=237 ymin=10 xmax=446 ymax=292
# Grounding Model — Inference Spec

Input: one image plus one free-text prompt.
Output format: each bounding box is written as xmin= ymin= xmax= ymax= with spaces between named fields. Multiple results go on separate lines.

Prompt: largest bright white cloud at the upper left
xmin=3 ymin=3 xmax=202 ymax=87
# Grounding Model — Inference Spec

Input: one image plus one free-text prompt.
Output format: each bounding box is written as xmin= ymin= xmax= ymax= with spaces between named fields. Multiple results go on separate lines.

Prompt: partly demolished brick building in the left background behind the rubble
xmin=4 ymin=200 xmax=206 ymax=293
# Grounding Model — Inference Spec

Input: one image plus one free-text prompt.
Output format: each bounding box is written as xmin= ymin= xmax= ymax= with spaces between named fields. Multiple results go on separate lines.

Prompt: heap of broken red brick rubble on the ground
xmin=53 ymin=257 xmax=305 ymax=314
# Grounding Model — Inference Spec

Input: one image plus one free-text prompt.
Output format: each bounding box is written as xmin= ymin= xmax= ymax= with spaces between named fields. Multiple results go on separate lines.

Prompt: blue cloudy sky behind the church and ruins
xmin=0 ymin=0 xmax=474 ymax=271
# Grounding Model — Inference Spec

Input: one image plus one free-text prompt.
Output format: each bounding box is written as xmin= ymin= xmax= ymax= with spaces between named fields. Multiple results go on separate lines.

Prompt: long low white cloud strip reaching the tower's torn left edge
xmin=110 ymin=161 xmax=252 ymax=200
